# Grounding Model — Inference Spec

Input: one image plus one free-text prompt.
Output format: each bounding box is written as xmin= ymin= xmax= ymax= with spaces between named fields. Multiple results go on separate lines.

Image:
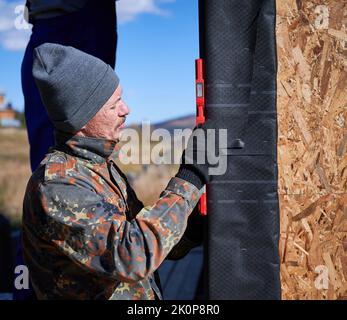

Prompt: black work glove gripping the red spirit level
xmin=176 ymin=122 xmax=215 ymax=190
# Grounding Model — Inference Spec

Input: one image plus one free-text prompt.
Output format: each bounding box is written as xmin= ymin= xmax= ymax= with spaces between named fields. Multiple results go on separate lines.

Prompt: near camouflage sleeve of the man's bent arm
xmin=40 ymin=178 xmax=202 ymax=282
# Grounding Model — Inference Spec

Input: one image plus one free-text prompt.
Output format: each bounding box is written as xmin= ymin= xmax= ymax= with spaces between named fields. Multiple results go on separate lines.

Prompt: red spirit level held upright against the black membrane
xmin=195 ymin=59 xmax=207 ymax=216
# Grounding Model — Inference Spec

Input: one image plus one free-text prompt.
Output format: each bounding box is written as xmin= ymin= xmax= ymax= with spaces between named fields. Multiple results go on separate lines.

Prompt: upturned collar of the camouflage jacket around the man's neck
xmin=54 ymin=131 xmax=119 ymax=164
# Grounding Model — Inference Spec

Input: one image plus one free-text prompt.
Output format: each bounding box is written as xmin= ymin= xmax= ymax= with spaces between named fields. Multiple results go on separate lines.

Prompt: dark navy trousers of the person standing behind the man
xmin=14 ymin=0 xmax=117 ymax=300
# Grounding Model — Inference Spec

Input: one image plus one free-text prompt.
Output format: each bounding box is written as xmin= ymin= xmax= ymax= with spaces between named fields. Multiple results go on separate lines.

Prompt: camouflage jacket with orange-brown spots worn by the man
xmin=23 ymin=135 xmax=201 ymax=299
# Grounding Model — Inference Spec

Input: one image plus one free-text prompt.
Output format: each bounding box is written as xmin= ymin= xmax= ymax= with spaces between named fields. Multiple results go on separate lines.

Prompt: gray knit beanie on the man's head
xmin=33 ymin=43 xmax=119 ymax=133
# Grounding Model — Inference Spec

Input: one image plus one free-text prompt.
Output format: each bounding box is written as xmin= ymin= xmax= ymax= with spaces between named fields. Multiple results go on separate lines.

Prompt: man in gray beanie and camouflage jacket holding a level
xmin=23 ymin=43 xmax=209 ymax=299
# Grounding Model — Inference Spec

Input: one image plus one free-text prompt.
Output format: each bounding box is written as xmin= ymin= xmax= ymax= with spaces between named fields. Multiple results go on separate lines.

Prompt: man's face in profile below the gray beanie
xmin=77 ymin=85 xmax=129 ymax=141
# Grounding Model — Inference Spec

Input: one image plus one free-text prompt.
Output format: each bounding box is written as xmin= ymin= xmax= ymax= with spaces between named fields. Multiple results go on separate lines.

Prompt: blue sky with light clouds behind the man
xmin=0 ymin=0 xmax=198 ymax=123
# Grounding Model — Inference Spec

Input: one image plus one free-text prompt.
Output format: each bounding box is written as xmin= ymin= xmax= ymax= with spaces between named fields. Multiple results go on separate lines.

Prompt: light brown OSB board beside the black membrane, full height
xmin=277 ymin=0 xmax=347 ymax=299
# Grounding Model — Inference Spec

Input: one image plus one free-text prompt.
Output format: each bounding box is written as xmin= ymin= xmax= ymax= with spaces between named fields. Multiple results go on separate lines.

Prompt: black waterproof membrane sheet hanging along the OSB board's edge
xmin=199 ymin=0 xmax=280 ymax=299
